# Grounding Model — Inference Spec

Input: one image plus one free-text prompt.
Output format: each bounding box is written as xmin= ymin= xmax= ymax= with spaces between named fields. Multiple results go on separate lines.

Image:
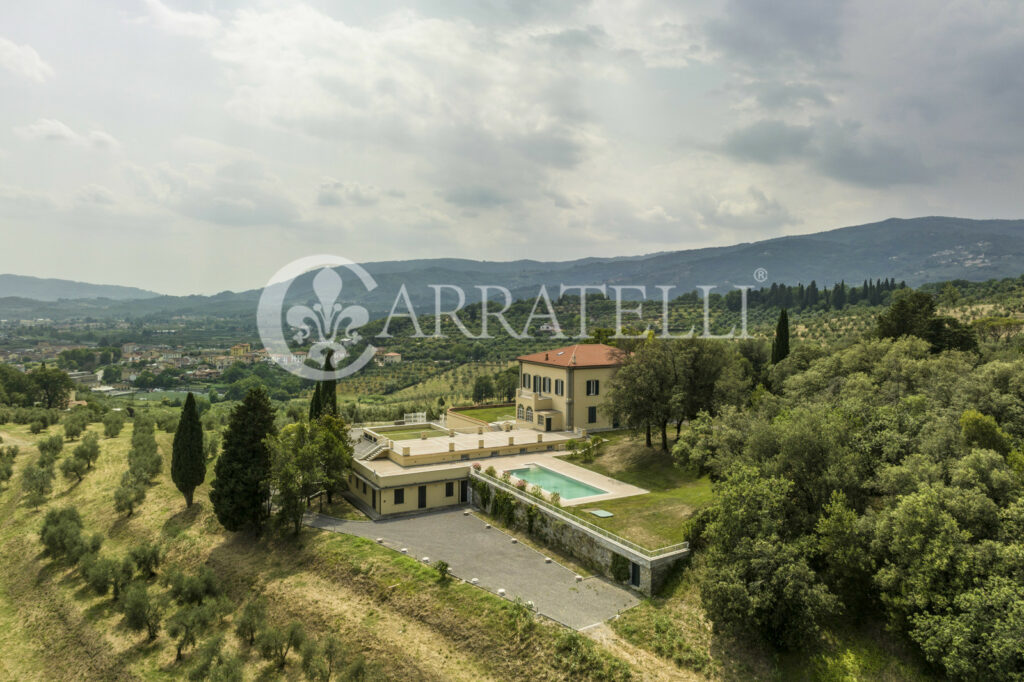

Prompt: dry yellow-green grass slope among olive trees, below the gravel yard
xmin=0 ymin=425 xmax=624 ymax=680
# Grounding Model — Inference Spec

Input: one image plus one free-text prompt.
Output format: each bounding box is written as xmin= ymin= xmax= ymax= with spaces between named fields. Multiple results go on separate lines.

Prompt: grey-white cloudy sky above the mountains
xmin=0 ymin=0 xmax=1024 ymax=294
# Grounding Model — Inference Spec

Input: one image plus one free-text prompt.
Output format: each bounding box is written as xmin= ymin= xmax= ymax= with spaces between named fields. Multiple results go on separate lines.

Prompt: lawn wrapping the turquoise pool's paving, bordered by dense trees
xmin=566 ymin=434 xmax=712 ymax=549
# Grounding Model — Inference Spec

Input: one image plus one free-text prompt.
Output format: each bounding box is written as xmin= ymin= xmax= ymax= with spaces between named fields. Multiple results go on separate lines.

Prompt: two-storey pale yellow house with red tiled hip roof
xmin=515 ymin=343 xmax=623 ymax=431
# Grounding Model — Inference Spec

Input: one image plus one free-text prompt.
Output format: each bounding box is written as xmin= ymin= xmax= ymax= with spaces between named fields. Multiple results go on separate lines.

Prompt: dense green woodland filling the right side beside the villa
xmin=608 ymin=290 xmax=1024 ymax=679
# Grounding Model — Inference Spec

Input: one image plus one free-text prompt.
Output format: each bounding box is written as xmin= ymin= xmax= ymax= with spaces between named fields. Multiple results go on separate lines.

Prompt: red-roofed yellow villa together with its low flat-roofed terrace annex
xmin=349 ymin=344 xmax=622 ymax=518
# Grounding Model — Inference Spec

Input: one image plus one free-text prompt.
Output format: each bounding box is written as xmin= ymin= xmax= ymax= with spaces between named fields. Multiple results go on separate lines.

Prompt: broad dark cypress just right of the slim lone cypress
xmin=210 ymin=387 xmax=276 ymax=534
